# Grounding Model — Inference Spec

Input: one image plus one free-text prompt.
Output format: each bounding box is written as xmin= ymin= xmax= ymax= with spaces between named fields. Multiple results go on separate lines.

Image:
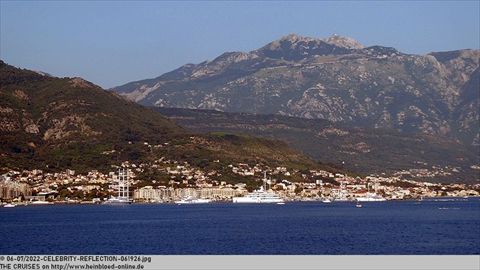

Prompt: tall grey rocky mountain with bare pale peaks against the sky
xmin=113 ymin=34 xmax=480 ymax=148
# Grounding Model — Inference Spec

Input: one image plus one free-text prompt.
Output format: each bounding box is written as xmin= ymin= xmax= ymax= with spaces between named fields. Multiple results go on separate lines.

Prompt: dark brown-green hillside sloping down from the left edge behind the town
xmin=0 ymin=61 xmax=320 ymax=175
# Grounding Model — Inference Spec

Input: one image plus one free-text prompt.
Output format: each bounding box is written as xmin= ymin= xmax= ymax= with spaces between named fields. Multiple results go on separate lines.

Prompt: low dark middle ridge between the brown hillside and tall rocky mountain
xmin=155 ymin=107 xmax=479 ymax=182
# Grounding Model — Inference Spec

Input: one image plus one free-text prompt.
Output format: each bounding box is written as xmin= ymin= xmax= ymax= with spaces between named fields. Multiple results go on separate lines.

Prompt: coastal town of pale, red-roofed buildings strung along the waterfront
xmin=0 ymin=158 xmax=480 ymax=204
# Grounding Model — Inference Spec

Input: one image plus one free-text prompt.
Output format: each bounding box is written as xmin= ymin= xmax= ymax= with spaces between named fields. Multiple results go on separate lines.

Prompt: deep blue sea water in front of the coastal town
xmin=0 ymin=198 xmax=480 ymax=255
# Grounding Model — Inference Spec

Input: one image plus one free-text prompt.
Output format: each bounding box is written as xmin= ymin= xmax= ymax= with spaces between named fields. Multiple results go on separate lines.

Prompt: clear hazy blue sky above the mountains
xmin=0 ymin=0 xmax=480 ymax=88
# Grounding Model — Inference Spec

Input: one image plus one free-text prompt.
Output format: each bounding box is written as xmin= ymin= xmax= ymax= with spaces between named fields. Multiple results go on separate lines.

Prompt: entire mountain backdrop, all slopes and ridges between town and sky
xmin=0 ymin=34 xmax=480 ymax=182
